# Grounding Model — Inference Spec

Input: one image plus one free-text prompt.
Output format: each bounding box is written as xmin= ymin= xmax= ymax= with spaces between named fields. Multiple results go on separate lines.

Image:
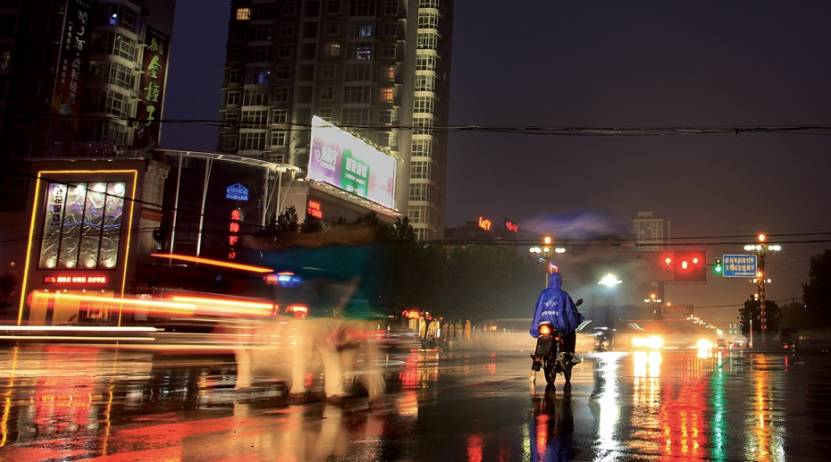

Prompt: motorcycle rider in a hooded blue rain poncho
xmin=530 ymin=265 xmax=584 ymax=364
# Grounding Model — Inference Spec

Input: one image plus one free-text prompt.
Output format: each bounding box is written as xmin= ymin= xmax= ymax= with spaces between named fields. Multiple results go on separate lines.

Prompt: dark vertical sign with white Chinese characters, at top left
xmin=52 ymin=0 xmax=94 ymax=117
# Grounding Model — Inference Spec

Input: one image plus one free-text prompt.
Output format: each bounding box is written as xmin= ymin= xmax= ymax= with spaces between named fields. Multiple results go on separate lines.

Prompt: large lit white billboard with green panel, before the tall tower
xmin=308 ymin=116 xmax=397 ymax=208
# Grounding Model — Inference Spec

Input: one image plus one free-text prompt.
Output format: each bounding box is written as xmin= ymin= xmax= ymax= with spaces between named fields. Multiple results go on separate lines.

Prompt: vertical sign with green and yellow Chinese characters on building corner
xmin=134 ymin=27 xmax=170 ymax=147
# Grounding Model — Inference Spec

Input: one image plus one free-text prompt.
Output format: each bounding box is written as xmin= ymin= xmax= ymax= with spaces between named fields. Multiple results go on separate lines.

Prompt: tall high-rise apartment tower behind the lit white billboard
xmin=218 ymin=0 xmax=453 ymax=240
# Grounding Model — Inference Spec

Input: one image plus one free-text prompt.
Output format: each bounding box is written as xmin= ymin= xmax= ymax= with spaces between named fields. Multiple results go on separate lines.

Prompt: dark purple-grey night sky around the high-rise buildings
xmin=163 ymin=0 xmax=831 ymax=319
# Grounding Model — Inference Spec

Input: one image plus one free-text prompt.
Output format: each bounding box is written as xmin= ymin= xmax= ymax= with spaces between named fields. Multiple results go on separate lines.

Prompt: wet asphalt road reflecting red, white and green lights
xmin=0 ymin=346 xmax=831 ymax=461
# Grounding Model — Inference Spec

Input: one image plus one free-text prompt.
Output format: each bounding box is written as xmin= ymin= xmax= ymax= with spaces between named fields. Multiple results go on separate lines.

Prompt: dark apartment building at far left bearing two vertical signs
xmin=0 ymin=0 xmax=175 ymax=206
